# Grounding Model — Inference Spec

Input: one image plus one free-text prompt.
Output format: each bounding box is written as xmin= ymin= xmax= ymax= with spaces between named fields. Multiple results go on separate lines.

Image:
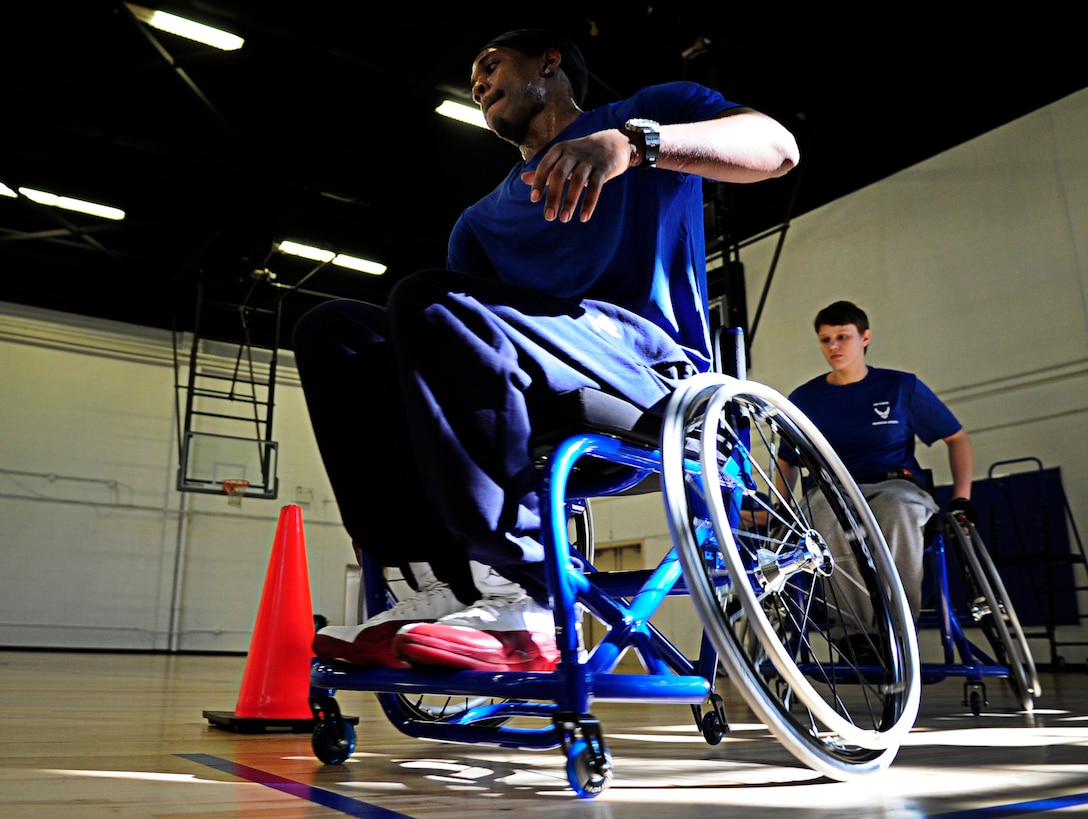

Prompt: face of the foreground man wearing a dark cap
xmin=470 ymin=46 xmax=545 ymax=145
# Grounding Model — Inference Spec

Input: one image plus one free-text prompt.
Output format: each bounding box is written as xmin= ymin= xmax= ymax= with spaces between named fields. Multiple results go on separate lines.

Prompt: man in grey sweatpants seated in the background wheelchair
xmin=780 ymin=301 xmax=975 ymax=631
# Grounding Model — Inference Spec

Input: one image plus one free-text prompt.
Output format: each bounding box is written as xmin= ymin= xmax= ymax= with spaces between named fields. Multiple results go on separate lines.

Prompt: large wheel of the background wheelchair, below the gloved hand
xmin=944 ymin=512 xmax=1041 ymax=711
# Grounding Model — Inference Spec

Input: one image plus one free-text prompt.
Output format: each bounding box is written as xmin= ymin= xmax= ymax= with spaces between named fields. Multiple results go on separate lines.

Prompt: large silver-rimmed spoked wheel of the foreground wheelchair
xmin=662 ymin=373 xmax=920 ymax=780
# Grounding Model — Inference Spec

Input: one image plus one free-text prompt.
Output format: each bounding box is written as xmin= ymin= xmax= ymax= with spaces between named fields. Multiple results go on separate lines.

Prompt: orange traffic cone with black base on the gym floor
xmin=203 ymin=504 xmax=314 ymax=733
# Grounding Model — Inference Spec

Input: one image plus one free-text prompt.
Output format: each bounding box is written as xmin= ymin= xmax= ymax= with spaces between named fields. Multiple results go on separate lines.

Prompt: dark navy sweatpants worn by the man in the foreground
xmin=294 ymin=270 xmax=693 ymax=600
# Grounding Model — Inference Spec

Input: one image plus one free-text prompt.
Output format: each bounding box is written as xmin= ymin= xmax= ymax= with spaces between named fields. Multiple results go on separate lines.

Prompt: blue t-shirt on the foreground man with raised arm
xmin=446 ymin=82 xmax=737 ymax=371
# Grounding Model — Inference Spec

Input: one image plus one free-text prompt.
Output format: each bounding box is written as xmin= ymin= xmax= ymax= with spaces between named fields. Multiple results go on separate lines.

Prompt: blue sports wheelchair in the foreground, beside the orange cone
xmin=310 ymin=331 xmax=920 ymax=797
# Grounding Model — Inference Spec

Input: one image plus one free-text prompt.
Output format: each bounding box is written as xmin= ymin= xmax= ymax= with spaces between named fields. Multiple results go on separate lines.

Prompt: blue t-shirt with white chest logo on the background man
xmin=779 ymin=367 xmax=962 ymax=480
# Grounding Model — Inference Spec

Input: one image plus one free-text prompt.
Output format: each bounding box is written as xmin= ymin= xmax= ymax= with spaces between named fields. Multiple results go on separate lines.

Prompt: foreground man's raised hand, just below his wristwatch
xmin=521 ymin=129 xmax=634 ymax=222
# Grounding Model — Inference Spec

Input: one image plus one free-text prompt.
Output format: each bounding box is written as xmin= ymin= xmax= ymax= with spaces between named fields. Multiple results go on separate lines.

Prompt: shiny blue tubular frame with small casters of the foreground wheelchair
xmin=311 ymin=422 xmax=727 ymax=795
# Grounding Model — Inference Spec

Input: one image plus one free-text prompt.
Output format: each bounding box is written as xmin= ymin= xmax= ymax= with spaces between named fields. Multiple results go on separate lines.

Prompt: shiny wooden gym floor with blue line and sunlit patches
xmin=0 ymin=650 xmax=1088 ymax=819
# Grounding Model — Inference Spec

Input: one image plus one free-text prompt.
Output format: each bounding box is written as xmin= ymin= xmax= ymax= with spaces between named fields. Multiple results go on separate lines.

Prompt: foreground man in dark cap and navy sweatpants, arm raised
xmin=294 ymin=29 xmax=799 ymax=670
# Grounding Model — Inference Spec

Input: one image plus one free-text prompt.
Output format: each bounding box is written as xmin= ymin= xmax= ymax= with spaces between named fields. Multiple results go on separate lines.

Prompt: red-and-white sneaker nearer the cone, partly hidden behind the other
xmin=313 ymin=563 xmax=465 ymax=668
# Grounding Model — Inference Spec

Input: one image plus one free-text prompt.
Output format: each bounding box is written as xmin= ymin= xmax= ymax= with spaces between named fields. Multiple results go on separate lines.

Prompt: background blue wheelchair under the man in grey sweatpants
xmin=918 ymin=512 xmax=1042 ymax=717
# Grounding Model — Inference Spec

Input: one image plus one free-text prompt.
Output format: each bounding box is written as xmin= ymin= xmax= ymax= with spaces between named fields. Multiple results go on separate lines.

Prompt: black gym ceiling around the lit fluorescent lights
xmin=0 ymin=0 xmax=1088 ymax=346
